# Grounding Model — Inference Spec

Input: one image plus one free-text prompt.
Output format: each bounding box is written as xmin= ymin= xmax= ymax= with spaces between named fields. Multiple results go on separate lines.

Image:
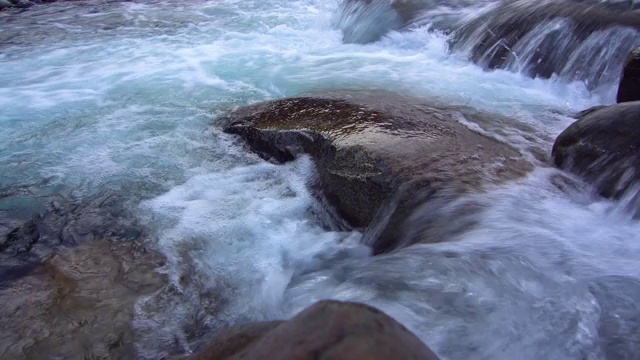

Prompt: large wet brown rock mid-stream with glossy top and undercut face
xmin=221 ymin=92 xmax=531 ymax=253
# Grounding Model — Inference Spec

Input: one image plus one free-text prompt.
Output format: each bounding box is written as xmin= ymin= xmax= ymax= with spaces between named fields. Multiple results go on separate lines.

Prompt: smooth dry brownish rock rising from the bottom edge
xmin=190 ymin=301 xmax=437 ymax=360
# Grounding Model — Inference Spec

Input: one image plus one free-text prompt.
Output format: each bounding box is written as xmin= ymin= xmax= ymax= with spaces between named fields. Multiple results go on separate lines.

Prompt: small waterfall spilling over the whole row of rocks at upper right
xmin=334 ymin=0 xmax=640 ymax=90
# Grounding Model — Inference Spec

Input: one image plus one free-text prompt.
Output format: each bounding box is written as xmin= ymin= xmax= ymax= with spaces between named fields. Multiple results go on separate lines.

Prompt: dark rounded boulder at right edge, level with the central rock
xmin=552 ymin=101 xmax=640 ymax=197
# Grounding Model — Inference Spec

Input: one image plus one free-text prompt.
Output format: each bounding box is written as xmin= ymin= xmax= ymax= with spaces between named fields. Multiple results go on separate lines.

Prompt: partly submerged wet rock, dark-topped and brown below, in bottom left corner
xmin=0 ymin=192 xmax=166 ymax=359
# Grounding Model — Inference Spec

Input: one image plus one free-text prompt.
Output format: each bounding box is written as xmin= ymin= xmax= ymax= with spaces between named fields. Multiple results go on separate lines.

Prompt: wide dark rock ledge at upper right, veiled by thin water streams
xmin=451 ymin=0 xmax=640 ymax=88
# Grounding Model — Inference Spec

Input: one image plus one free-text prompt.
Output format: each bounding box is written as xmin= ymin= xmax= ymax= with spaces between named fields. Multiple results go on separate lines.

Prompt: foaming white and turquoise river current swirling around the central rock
xmin=0 ymin=0 xmax=640 ymax=359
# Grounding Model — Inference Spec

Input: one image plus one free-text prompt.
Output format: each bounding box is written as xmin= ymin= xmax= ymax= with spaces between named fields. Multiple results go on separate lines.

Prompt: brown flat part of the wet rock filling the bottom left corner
xmin=0 ymin=240 xmax=165 ymax=359
